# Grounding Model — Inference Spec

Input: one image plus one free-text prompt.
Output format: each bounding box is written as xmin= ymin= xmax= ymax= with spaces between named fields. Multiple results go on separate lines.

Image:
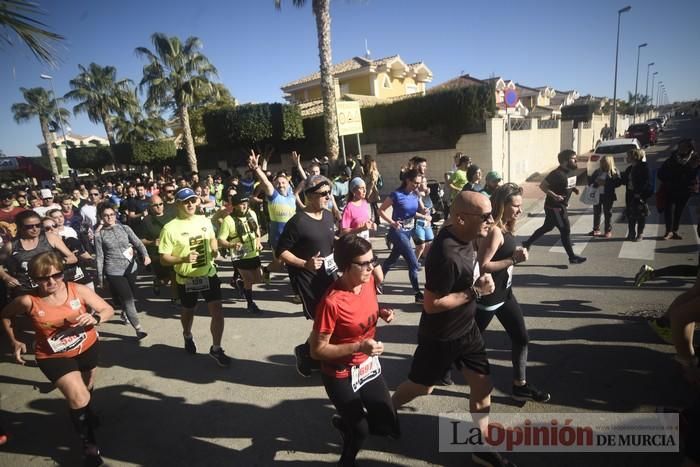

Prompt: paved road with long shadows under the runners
xmin=0 ymin=115 xmax=700 ymax=467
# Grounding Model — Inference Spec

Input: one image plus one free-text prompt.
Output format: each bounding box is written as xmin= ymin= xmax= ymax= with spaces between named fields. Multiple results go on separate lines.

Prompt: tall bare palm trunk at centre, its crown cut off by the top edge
xmin=275 ymin=0 xmax=339 ymax=160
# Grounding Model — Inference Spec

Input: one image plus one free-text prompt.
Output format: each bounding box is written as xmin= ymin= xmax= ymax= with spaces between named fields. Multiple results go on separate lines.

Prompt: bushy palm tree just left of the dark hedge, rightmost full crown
xmin=136 ymin=32 xmax=217 ymax=172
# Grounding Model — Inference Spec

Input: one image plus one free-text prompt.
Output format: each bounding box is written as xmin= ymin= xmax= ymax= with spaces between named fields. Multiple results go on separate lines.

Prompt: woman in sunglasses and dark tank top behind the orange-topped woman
xmin=0 ymin=211 xmax=78 ymax=297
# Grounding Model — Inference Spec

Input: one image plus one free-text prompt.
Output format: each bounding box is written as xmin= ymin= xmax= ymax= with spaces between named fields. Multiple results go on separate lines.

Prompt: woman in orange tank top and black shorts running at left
xmin=2 ymin=252 xmax=114 ymax=466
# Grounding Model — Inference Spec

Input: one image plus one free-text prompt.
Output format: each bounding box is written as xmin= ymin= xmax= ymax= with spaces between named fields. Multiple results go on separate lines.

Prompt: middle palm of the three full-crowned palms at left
xmin=65 ymin=63 xmax=134 ymax=145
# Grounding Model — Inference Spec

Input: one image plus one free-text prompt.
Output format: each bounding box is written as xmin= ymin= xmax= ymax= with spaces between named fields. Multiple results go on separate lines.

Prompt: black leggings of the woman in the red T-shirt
xmin=321 ymin=374 xmax=399 ymax=466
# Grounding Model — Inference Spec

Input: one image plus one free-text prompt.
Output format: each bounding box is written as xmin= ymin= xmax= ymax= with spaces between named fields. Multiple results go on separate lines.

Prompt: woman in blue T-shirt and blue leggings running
xmin=379 ymin=169 xmax=425 ymax=303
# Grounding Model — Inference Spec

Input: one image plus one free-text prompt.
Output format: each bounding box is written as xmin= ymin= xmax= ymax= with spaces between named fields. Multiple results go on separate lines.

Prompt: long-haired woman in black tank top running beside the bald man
xmin=476 ymin=183 xmax=550 ymax=402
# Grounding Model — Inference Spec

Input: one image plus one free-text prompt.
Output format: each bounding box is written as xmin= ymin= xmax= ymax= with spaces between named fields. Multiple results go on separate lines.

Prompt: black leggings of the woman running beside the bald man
xmin=475 ymin=292 xmax=529 ymax=381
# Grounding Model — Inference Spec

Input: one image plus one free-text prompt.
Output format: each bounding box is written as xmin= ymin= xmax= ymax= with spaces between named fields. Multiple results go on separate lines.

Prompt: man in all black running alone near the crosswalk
xmin=523 ymin=149 xmax=586 ymax=264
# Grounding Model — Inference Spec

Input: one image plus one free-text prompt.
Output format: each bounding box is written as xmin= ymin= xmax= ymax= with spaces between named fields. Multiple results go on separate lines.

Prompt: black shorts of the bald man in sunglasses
xmin=408 ymin=324 xmax=490 ymax=386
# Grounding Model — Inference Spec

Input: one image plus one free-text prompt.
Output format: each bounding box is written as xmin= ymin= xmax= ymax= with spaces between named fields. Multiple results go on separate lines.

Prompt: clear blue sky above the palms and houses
xmin=0 ymin=0 xmax=700 ymax=156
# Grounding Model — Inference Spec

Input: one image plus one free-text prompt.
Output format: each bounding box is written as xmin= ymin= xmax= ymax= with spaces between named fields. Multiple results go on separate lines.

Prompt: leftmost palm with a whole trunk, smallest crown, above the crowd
xmin=12 ymin=88 xmax=70 ymax=177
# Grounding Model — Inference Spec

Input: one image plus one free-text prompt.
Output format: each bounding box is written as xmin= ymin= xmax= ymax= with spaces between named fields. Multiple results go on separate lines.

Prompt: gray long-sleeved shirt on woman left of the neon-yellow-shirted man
xmin=95 ymin=224 xmax=148 ymax=281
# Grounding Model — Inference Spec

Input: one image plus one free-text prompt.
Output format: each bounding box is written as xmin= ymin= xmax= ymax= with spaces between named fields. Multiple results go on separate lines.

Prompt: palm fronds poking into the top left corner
xmin=0 ymin=0 xmax=65 ymax=66
